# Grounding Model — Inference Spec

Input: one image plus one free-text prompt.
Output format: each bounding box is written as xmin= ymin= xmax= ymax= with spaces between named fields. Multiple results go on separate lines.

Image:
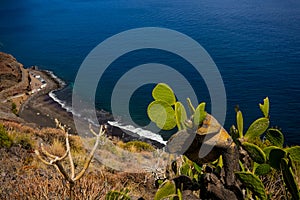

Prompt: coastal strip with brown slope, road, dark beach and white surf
xmin=0 ymin=52 xmax=165 ymax=148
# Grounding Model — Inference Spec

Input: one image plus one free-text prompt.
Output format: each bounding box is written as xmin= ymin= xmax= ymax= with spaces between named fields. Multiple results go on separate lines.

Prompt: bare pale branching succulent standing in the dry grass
xmin=35 ymin=120 xmax=105 ymax=200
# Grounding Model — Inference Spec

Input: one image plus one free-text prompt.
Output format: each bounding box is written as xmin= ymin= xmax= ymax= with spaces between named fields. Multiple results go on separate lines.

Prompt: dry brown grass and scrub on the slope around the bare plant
xmin=0 ymin=122 xmax=156 ymax=199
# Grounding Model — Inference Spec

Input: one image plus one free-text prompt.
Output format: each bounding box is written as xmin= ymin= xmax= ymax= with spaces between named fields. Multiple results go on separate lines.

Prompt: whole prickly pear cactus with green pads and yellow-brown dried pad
xmin=147 ymin=88 xmax=300 ymax=200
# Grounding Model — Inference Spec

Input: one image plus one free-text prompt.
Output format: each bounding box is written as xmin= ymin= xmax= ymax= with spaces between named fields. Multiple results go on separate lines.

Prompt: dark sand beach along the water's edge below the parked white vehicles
xmin=19 ymin=69 xmax=165 ymax=148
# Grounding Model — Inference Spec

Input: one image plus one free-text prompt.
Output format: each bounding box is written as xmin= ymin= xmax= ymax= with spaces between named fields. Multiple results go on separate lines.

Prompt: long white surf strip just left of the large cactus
xmin=107 ymin=121 xmax=167 ymax=145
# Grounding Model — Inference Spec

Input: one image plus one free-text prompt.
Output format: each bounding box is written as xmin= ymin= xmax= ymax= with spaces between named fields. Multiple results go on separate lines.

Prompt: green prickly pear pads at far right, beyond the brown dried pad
xmin=231 ymin=98 xmax=300 ymax=199
